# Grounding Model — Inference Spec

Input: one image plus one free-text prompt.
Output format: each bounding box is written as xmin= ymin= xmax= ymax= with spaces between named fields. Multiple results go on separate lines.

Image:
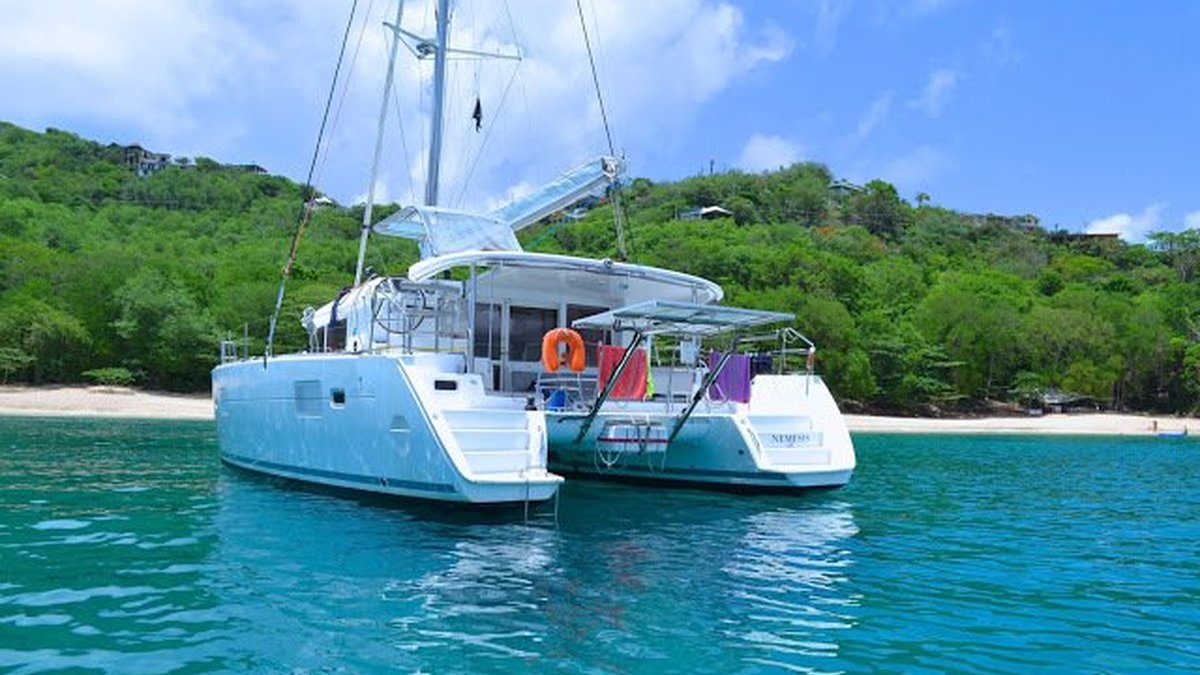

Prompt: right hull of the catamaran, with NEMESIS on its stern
xmin=546 ymin=375 xmax=856 ymax=491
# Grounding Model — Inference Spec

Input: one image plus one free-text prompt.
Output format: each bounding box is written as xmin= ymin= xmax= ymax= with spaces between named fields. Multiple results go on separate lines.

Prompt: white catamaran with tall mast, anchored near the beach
xmin=212 ymin=0 xmax=856 ymax=503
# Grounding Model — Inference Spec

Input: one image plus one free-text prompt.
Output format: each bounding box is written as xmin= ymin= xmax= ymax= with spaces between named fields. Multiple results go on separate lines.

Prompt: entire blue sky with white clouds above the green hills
xmin=0 ymin=0 xmax=1200 ymax=241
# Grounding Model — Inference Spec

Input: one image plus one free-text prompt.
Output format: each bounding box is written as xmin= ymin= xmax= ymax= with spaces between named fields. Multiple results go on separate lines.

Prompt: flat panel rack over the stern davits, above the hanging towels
xmin=571 ymin=300 xmax=796 ymax=335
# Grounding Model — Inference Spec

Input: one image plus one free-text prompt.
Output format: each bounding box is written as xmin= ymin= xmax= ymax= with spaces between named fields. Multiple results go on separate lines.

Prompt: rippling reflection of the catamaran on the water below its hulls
xmin=208 ymin=471 xmax=856 ymax=673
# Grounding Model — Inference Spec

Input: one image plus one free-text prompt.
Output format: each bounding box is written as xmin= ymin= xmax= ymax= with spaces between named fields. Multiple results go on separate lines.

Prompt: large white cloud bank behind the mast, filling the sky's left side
xmin=0 ymin=0 xmax=796 ymax=207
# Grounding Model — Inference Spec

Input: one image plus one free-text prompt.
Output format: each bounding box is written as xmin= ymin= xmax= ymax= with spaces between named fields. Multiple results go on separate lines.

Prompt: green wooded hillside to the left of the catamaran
xmin=0 ymin=124 xmax=415 ymax=390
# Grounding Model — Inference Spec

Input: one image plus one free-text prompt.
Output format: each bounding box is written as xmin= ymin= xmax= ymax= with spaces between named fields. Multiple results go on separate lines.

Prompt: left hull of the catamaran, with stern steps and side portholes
xmin=212 ymin=353 xmax=562 ymax=503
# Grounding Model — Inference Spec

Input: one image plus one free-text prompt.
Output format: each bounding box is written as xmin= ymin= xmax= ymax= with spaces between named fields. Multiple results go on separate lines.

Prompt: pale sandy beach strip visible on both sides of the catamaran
xmin=0 ymin=386 xmax=1200 ymax=436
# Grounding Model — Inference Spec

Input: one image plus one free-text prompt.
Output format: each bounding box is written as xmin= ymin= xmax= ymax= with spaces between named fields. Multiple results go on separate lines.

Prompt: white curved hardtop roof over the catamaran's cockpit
xmin=408 ymin=251 xmax=725 ymax=306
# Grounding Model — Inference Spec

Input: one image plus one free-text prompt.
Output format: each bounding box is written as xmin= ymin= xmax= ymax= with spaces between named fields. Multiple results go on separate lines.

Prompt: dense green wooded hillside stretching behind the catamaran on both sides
xmin=0 ymin=124 xmax=1200 ymax=412
